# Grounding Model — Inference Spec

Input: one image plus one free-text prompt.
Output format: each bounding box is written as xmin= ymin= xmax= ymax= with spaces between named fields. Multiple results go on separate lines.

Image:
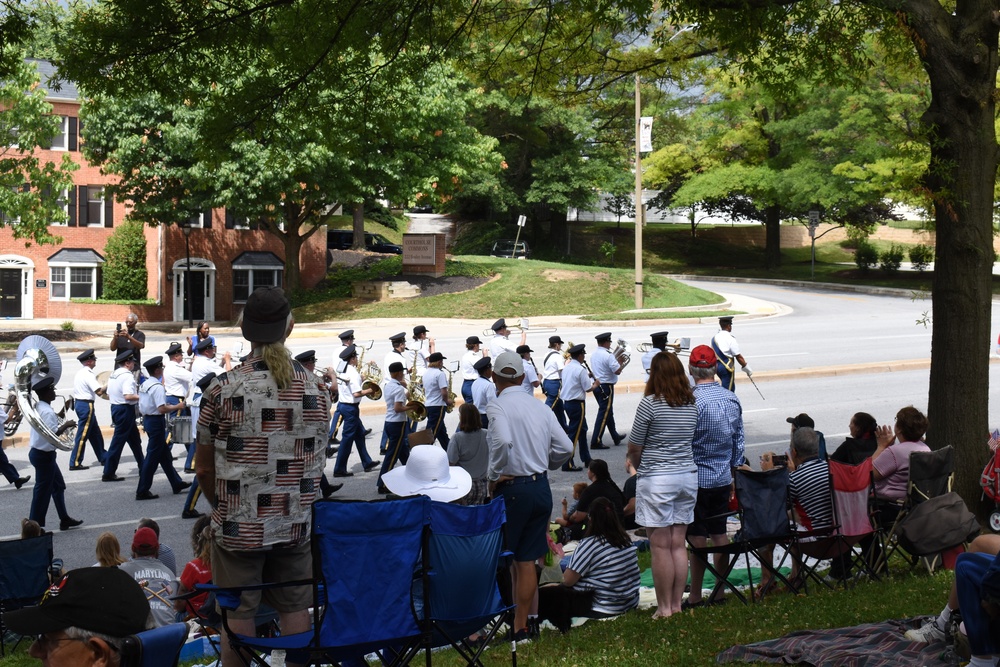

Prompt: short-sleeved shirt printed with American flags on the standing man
xmin=198 ymin=355 xmax=330 ymax=551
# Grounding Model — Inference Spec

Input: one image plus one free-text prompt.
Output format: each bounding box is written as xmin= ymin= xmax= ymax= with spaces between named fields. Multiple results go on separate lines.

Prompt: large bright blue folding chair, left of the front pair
xmin=207 ymin=496 xmax=431 ymax=667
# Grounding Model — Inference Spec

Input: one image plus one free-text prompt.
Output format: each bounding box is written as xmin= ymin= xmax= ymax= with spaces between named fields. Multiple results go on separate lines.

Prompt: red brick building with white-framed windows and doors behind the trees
xmin=0 ymin=61 xmax=327 ymax=322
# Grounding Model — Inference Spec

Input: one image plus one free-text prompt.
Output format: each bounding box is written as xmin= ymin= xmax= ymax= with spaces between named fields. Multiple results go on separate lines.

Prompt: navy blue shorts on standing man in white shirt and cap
xmin=497 ymin=478 xmax=552 ymax=563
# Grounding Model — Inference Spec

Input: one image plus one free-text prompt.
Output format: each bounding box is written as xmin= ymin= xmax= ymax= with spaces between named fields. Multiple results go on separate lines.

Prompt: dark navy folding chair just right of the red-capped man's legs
xmin=688 ymin=468 xmax=793 ymax=604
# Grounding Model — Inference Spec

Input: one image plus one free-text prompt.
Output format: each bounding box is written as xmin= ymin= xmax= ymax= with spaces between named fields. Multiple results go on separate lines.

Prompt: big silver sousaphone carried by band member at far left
xmin=14 ymin=335 xmax=76 ymax=451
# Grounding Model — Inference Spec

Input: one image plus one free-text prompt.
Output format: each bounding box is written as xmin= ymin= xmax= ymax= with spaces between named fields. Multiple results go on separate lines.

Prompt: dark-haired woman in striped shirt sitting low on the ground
xmin=538 ymin=498 xmax=640 ymax=632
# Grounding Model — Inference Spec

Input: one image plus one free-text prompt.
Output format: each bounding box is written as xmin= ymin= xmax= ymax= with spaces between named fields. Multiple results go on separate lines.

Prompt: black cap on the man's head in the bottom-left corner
xmin=3 ymin=567 xmax=149 ymax=637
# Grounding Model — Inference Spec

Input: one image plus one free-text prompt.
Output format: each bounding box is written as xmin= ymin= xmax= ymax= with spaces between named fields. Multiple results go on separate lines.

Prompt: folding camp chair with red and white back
xmin=792 ymin=459 xmax=878 ymax=589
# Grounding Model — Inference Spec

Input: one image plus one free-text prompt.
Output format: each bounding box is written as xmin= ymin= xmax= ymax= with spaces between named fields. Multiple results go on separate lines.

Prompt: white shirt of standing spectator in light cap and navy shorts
xmin=486 ymin=387 xmax=573 ymax=480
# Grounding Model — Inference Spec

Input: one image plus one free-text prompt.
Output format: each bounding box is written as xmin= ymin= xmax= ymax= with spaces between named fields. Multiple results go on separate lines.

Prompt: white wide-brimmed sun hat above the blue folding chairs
xmin=382 ymin=445 xmax=472 ymax=503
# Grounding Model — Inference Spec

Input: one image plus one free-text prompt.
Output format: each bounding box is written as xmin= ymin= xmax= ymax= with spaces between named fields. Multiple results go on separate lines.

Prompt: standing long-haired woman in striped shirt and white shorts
xmin=628 ymin=352 xmax=698 ymax=618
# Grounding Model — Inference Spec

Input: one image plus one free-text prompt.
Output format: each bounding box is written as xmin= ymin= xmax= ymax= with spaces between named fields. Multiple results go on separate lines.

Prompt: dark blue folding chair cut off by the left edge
xmin=0 ymin=533 xmax=52 ymax=656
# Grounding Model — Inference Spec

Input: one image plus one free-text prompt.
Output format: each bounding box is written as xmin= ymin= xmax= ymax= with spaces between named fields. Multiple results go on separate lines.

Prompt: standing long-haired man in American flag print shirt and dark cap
xmin=195 ymin=288 xmax=330 ymax=667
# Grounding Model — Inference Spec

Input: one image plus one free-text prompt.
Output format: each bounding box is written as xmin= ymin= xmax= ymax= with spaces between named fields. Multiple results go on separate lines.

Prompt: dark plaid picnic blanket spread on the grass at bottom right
xmin=715 ymin=616 xmax=955 ymax=667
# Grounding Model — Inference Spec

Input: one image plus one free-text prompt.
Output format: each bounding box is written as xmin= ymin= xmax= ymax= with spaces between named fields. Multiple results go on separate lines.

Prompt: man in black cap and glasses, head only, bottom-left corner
xmin=3 ymin=567 xmax=152 ymax=667
